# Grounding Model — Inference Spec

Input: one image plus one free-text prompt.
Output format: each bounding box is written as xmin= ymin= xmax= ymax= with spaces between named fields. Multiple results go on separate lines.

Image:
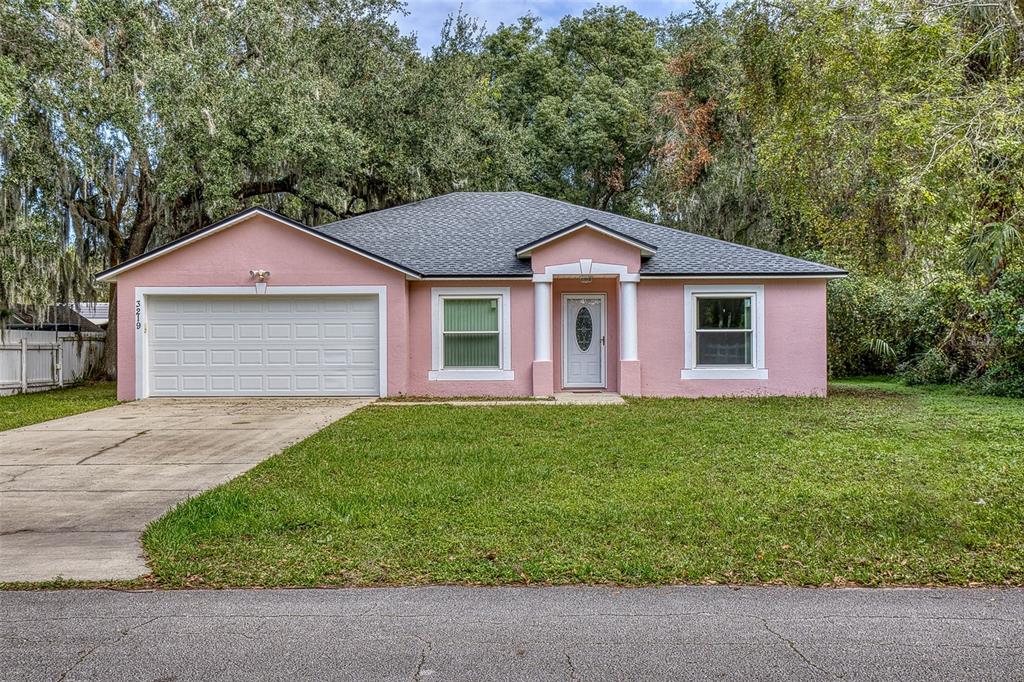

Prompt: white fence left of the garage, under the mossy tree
xmin=0 ymin=330 xmax=104 ymax=395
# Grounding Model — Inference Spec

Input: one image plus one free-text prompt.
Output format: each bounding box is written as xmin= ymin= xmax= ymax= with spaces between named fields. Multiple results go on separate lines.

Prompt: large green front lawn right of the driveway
xmin=144 ymin=382 xmax=1024 ymax=587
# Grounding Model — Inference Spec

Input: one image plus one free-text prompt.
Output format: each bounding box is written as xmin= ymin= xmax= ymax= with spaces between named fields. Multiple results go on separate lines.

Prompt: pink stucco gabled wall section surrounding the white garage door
xmin=117 ymin=215 xmax=409 ymax=400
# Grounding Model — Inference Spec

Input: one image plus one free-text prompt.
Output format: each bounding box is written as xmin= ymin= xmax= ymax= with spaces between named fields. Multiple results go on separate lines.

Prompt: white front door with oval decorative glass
xmin=562 ymin=294 xmax=605 ymax=388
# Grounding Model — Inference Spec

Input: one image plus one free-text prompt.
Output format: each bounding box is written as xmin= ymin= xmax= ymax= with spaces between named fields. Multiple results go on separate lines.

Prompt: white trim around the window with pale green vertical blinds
xmin=427 ymin=287 xmax=515 ymax=381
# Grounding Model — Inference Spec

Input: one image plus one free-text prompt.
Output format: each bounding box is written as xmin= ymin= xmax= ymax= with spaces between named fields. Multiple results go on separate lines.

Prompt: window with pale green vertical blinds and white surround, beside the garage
xmin=428 ymin=287 xmax=515 ymax=381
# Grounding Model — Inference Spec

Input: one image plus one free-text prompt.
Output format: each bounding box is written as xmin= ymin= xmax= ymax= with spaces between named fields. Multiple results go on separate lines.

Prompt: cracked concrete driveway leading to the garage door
xmin=0 ymin=398 xmax=370 ymax=582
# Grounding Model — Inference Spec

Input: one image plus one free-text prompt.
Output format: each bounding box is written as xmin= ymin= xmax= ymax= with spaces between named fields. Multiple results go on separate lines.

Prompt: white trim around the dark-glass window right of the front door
xmin=679 ymin=285 xmax=768 ymax=380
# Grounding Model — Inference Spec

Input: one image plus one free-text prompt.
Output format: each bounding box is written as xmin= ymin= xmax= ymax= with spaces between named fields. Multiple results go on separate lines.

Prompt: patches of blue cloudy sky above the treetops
xmin=395 ymin=0 xmax=693 ymax=51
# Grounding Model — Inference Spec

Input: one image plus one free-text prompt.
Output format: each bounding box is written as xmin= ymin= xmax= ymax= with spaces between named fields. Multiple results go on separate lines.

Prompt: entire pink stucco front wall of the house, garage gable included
xmin=112 ymin=216 xmax=826 ymax=399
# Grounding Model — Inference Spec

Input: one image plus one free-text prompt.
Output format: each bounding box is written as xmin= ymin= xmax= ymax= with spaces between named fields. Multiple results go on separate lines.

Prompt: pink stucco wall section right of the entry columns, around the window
xmin=637 ymin=280 xmax=827 ymax=397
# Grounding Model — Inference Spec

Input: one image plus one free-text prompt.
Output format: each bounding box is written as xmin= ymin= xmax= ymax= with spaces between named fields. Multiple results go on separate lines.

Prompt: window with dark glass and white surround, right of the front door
xmin=681 ymin=285 xmax=768 ymax=379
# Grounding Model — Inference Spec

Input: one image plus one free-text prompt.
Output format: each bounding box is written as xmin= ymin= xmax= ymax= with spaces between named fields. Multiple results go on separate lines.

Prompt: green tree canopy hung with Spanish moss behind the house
xmin=0 ymin=0 xmax=1024 ymax=385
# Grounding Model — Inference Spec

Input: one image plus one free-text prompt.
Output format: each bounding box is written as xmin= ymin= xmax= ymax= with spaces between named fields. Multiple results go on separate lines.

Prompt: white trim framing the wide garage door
xmin=132 ymin=286 xmax=387 ymax=400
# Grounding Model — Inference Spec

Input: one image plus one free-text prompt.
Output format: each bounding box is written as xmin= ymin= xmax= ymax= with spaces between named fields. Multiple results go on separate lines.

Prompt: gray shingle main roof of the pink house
xmin=315 ymin=191 xmax=844 ymax=276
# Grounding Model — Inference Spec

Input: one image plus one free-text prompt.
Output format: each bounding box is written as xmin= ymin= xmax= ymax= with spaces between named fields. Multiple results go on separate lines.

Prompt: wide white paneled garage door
xmin=146 ymin=295 xmax=380 ymax=395
